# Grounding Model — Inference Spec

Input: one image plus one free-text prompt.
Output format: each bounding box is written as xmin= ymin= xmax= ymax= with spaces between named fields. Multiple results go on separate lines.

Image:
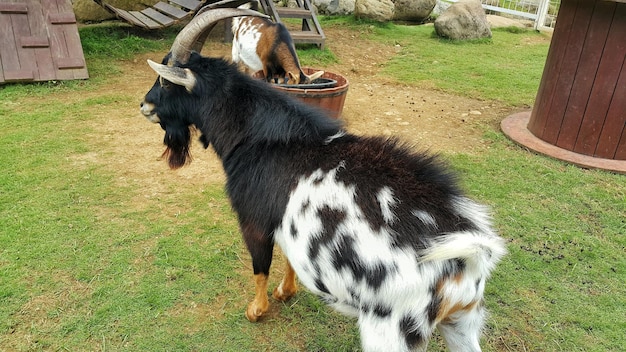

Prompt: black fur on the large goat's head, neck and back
xmin=145 ymin=53 xmax=471 ymax=278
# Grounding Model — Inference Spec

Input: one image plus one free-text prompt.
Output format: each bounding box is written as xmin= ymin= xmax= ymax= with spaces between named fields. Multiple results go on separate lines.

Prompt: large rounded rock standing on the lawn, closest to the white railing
xmin=435 ymin=0 xmax=491 ymax=40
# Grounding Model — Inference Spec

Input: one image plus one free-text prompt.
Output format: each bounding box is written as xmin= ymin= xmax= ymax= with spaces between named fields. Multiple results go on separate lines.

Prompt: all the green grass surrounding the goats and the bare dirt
xmin=0 ymin=18 xmax=626 ymax=351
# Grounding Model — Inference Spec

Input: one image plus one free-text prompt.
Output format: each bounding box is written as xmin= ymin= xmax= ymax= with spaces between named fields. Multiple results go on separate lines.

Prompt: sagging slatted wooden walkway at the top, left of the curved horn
xmin=94 ymin=0 xmax=206 ymax=29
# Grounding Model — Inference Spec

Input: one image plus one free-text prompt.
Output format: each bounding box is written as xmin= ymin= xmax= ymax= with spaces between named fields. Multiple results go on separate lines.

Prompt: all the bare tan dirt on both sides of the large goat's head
xmin=53 ymin=27 xmax=510 ymax=192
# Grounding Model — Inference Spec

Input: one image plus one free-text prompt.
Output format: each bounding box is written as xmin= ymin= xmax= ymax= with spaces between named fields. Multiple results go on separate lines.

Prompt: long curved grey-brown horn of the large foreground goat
xmin=167 ymin=8 xmax=267 ymax=66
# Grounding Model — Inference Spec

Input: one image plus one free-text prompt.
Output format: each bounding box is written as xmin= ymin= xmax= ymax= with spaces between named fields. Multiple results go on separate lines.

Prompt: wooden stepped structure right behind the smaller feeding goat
xmin=260 ymin=0 xmax=326 ymax=49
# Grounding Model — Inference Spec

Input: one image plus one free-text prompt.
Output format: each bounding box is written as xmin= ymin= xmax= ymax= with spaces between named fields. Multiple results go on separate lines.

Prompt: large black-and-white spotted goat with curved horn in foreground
xmin=141 ymin=9 xmax=506 ymax=351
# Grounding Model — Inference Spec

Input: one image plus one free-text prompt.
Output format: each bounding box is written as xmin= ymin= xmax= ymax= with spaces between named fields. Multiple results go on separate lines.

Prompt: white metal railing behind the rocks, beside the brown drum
xmin=443 ymin=0 xmax=561 ymax=30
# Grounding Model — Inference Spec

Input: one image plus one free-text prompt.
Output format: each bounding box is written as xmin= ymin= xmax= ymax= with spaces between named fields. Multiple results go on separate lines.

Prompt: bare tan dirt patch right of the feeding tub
xmin=310 ymin=28 xmax=510 ymax=153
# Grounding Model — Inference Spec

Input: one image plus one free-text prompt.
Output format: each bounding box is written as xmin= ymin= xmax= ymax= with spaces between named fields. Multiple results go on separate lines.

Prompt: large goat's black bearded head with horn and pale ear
xmin=140 ymin=8 xmax=265 ymax=169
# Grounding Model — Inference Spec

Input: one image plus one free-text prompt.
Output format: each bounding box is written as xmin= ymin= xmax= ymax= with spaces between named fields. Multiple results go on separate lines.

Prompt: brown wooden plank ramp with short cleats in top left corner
xmin=0 ymin=0 xmax=89 ymax=83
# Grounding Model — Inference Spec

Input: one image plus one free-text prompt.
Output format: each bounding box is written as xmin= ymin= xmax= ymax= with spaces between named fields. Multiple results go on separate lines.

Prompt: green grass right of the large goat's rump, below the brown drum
xmin=451 ymin=132 xmax=626 ymax=351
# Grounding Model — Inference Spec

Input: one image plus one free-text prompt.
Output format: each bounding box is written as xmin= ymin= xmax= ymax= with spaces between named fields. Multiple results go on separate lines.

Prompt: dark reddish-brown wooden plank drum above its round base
xmin=528 ymin=0 xmax=626 ymax=160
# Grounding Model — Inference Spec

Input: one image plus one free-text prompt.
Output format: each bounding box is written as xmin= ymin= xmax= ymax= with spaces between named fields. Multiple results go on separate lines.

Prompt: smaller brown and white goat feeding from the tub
xmin=232 ymin=4 xmax=324 ymax=84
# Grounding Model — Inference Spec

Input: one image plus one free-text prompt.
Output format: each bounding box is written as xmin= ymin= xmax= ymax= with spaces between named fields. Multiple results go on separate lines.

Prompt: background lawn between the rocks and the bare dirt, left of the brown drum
xmin=373 ymin=25 xmax=549 ymax=106
